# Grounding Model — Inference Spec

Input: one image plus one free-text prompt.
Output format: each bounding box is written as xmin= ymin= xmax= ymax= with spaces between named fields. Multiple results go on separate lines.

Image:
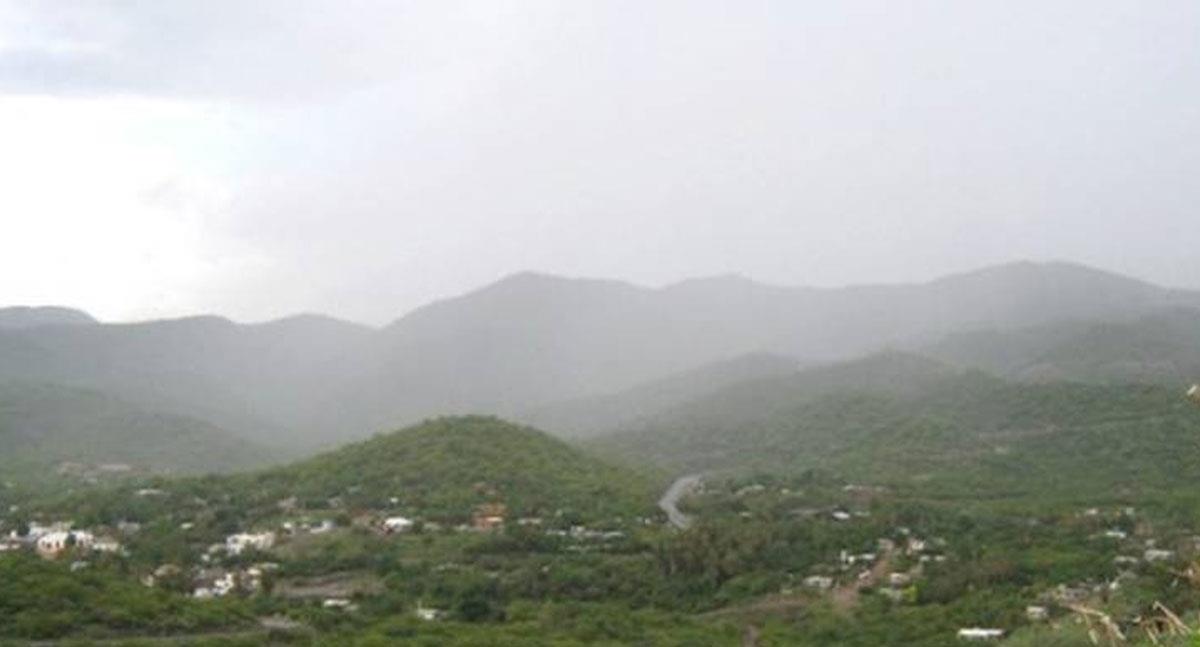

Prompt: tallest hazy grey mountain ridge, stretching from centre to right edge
xmin=333 ymin=263 xmax=1200 ymax=427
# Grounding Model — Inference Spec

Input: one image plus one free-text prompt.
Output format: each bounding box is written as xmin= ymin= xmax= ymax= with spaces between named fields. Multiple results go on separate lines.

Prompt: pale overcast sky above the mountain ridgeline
xmin=0 ymin=0 xmax=1200 ymax=323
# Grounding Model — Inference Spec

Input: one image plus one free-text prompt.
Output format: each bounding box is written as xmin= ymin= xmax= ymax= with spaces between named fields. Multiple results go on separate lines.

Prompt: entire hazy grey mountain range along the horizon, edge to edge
xmin=0 ymin=263 xmax=1200 ymax=450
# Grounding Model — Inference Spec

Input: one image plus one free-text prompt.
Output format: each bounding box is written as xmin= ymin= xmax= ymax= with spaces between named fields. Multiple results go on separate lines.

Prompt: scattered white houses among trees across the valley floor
xmin=7 ymin=470 xmax=1200 ymax=641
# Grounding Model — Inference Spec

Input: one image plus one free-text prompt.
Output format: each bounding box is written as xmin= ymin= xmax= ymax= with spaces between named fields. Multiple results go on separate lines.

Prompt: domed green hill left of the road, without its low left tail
xmin=248 ymin=417 xmax=652 ymax=516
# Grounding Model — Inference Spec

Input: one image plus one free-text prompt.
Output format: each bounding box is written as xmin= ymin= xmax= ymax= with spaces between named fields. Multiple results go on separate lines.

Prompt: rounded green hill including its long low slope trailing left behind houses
xmin=66 ymin=417 xmax=661 ymax=525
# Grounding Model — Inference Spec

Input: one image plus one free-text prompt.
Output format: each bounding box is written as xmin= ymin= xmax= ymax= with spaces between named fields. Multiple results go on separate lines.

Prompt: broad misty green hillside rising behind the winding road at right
xmin=594 ymin=358 xmax=1200 ymax=508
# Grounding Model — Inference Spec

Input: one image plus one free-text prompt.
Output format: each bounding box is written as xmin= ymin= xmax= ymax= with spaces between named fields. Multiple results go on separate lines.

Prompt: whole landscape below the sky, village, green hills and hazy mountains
xmin=0 ymin=265 xmax=1200 ymax=647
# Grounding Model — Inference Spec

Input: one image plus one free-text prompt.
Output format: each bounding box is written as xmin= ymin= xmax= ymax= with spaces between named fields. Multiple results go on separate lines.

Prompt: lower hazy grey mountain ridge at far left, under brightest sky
xmin=0 ymin=316 xmax=372 ymax=448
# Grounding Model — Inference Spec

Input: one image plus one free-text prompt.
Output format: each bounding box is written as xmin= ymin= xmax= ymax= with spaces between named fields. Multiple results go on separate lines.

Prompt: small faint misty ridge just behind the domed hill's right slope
xmin=518 ymin=353 xmax=800 ymax=437
